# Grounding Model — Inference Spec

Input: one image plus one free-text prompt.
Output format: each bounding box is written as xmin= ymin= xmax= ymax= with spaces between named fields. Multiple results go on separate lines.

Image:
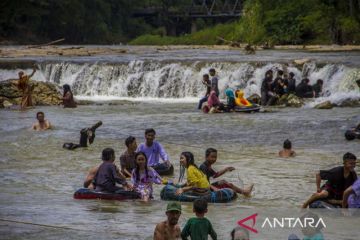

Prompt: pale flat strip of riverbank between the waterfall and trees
xmin=0 ymin=44 xmax=360 ymax=59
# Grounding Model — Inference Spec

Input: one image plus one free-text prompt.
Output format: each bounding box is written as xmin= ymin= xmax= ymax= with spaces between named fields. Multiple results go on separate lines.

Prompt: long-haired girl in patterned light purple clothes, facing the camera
xmin=131 ymin=152 xmax=162 ymax=202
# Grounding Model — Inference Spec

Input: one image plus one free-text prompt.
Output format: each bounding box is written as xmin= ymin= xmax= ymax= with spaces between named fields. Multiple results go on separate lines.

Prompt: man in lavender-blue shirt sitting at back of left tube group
xmin=136 ymin=128 xmax=171 ymax=170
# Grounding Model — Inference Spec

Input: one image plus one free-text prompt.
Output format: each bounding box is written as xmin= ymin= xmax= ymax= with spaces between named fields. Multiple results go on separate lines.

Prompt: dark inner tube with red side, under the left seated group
xmin=74 ymin=188 xmax=141 ymax=201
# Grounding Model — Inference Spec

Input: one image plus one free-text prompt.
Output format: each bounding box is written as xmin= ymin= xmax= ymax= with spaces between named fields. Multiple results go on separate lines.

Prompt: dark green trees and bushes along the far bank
xmin=0 ymin=0 xmax=360 ymax=44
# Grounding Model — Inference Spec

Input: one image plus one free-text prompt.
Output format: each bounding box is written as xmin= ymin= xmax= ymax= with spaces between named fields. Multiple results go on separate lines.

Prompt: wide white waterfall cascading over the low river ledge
xmin=0 ymin=60 xmax=360 ymax=102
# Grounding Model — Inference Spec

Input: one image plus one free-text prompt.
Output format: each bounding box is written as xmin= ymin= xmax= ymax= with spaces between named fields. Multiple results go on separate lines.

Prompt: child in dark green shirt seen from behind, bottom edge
xmin=181 ymin=198 xmax=217 ymax=240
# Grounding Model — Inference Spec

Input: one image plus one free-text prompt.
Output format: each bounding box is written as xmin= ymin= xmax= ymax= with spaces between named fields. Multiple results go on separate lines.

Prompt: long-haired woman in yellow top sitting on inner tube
xmin=176 ymin=152 xmax=210 ymax=195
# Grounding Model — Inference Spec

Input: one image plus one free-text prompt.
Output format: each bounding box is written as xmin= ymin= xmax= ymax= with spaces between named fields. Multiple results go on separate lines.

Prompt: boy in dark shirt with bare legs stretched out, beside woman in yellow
xmin=200 ymin=148 xmax=254 ymax=196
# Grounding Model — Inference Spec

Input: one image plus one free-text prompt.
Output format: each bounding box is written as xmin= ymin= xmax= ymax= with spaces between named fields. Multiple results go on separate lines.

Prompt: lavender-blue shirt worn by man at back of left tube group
xmin=136 ymin=141 xmax=169 ymax=166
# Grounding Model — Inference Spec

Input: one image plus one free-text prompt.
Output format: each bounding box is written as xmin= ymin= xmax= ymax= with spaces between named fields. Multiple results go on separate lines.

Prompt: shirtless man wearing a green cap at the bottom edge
xmin=154 ymin=202 xmax=181 ymax=240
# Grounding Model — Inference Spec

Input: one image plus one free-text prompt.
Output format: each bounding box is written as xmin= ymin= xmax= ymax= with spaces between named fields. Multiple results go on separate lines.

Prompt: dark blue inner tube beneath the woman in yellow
xmin=160 ymin=185 xmax=237 ymax=203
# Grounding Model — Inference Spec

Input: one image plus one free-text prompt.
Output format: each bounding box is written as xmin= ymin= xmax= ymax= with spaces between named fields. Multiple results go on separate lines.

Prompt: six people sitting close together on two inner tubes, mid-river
xmin=84 ymin=128 xmax=253 ymax=201
